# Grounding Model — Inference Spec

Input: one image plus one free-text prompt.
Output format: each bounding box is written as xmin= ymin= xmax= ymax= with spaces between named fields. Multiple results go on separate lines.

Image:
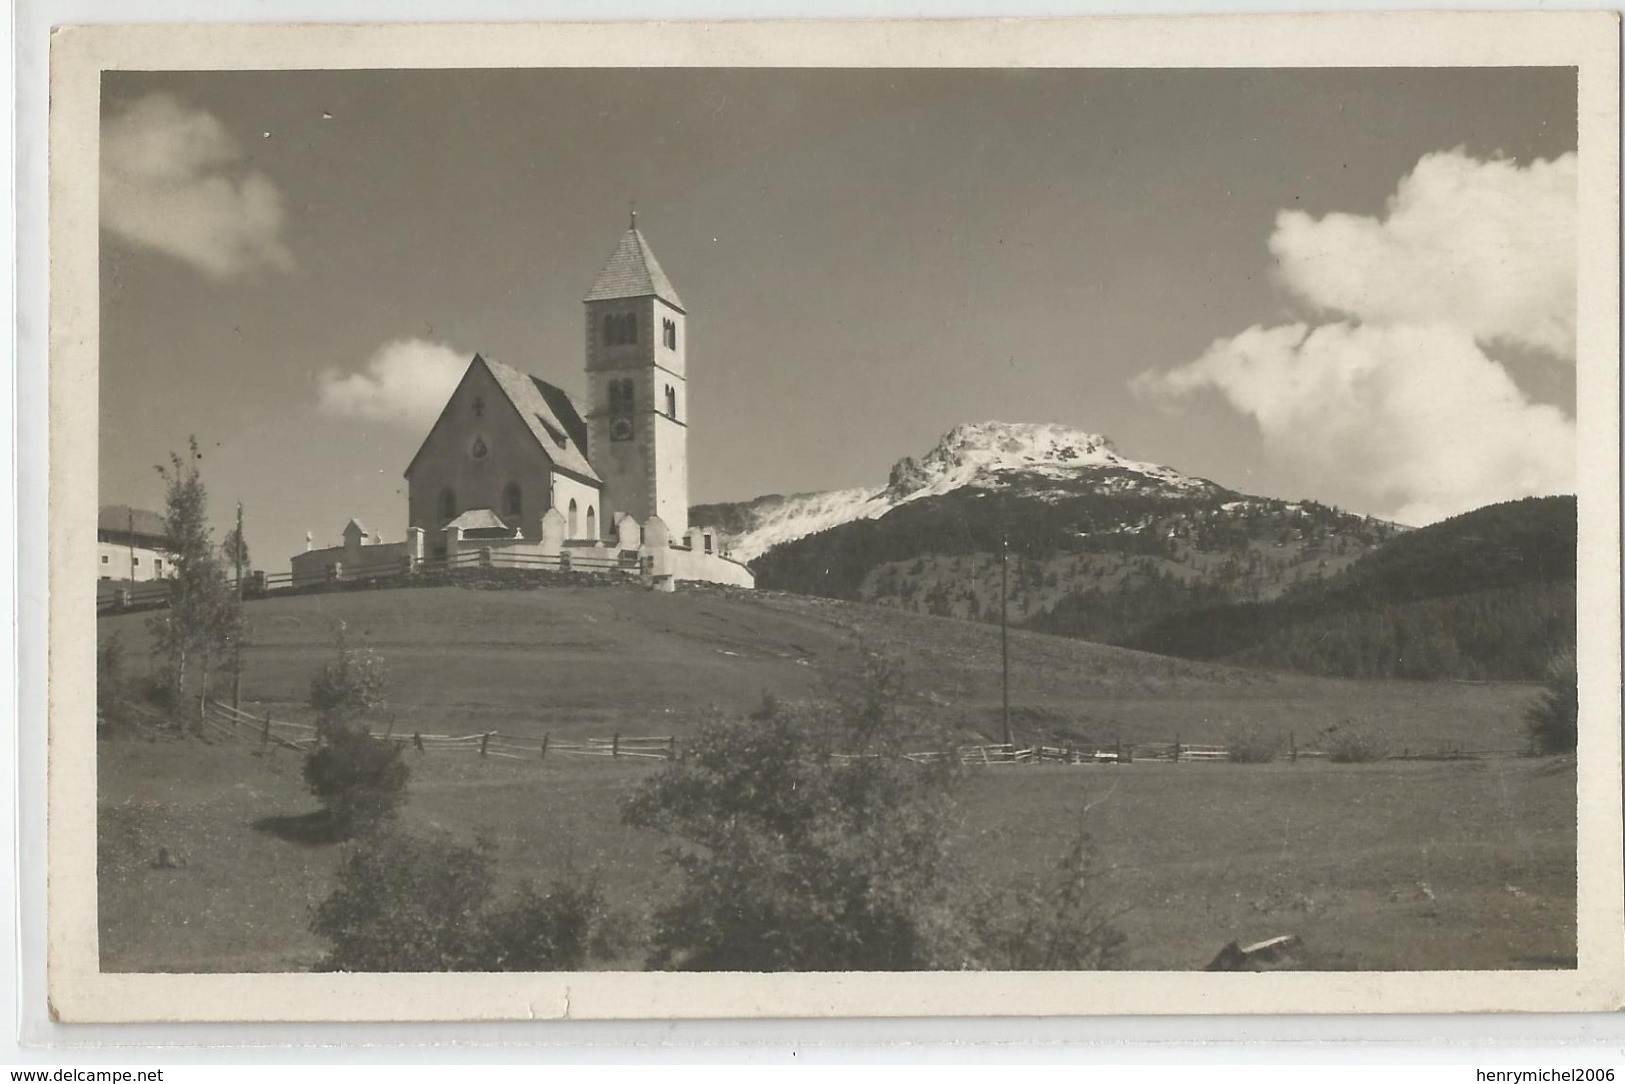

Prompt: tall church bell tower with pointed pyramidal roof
xmin=583 ymin=211 xmax=689 ymax=540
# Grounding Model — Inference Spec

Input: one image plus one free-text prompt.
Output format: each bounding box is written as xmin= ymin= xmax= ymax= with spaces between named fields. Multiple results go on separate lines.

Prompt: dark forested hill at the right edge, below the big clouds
xmin=1118 ymin=497 xmax=1576 ymax=679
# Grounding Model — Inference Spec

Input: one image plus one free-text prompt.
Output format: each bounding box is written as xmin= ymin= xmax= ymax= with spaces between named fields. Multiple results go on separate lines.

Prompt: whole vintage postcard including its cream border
xmin=49 ymin=13 xmax=1625 ymax=1021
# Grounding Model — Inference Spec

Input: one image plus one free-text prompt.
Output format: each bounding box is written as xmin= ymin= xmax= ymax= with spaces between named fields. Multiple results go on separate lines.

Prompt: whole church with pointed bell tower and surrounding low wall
xmin=293 ymin=211 xmax=754 ymax=590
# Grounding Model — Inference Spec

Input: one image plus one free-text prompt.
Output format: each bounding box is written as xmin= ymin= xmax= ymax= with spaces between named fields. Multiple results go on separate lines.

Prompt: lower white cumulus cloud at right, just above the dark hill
xmin=1134 ymin=323 xmax=1575 ymax=523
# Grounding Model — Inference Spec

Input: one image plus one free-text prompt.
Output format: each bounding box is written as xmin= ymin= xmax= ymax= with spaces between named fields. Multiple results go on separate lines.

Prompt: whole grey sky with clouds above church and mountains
xmin=99 ymin=68 xmax=1576 ymax=570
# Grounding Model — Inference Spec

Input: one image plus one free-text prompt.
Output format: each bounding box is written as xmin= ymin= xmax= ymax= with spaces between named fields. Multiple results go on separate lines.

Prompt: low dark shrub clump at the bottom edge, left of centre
xmin=310 ymin=832 xmax=619 ymax=972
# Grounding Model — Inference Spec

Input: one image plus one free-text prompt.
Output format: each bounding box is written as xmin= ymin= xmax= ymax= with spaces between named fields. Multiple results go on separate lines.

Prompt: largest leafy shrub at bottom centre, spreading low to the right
xmin=622 ymin=653 xmax=1131 ymax=970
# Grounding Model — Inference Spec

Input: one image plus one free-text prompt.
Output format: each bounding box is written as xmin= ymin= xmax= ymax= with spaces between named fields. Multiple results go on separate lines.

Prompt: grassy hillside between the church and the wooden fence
xmin=99 ymin=585 xmax=1534 ymax=749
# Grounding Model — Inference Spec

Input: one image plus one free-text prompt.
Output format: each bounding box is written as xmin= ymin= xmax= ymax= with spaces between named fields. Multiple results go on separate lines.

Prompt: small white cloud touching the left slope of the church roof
xmin=317 ymin=338 xmax=473 ymax=431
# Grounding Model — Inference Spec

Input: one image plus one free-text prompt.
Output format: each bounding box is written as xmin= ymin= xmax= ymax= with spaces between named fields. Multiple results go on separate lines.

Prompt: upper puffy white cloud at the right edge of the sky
xmin=1269 ymin=151 xmax=1578 ymax=359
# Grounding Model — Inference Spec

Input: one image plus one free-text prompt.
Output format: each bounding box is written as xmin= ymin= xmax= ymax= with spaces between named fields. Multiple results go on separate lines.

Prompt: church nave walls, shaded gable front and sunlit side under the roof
xmin=406 ymin=367 xmax=598 ymax=552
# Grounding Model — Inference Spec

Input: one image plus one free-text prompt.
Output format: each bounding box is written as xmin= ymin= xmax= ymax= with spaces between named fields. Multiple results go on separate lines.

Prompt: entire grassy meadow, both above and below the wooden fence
xmin=98 ymin=587 xmax=1575 ymax=972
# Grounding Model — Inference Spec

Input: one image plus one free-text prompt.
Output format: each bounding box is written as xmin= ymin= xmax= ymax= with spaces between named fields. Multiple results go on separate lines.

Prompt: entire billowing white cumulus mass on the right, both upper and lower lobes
xmin=1131 ymin=151 xmax=1576 ymax=525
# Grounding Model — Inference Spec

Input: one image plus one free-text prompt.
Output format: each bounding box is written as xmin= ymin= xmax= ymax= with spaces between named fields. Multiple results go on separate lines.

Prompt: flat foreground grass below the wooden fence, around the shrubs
xmin=99 ymin=741 xmax=1575 ymax=972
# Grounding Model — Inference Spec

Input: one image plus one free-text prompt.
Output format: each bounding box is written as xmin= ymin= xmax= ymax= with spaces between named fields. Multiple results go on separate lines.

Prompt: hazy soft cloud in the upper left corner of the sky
xmin=101 ymin=94 xmax=294 ymax=280
